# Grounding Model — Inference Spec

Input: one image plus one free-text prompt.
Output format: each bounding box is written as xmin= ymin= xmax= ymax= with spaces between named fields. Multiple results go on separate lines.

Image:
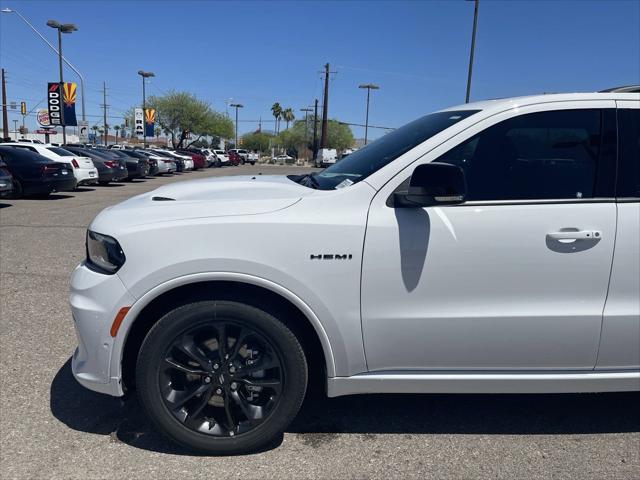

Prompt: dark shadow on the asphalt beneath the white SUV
xmin=50 ymin=359 xmax=640 ymax=455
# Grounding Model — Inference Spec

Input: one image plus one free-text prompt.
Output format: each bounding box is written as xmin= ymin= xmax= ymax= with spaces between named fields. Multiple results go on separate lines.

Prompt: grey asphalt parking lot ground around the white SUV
xmin=0 ymin=165 xmax=640 ymax=479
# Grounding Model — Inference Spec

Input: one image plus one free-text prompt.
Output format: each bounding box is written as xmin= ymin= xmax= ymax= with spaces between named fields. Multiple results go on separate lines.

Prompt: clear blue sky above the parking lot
xmin=0 ymin=0 xmax=640 ymax=137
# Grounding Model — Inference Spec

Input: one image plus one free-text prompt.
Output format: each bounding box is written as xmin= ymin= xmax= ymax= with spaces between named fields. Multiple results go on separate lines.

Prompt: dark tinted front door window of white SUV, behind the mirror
xmin=437 ymin=110 xmax=608 ymax=200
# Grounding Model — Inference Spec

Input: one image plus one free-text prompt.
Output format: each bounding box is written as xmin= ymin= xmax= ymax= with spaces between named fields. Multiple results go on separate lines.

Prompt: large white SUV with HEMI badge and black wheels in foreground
xmin=70 ymin=87 xmax=640 ymax=454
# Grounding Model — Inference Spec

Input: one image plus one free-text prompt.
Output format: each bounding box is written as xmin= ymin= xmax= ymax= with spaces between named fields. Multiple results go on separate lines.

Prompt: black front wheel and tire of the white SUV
xmin=136 ymin=301 xmax=307 ymax=455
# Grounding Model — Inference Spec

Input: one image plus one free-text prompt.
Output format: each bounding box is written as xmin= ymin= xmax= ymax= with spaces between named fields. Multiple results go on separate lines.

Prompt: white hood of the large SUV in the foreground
xmin=90 ymin=175 xmax=316 ymax=234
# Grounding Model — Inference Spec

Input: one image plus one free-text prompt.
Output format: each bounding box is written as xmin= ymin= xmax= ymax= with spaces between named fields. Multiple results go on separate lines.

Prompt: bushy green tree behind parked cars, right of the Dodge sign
xmin=147 ymin=90 xmax=234 ymax=148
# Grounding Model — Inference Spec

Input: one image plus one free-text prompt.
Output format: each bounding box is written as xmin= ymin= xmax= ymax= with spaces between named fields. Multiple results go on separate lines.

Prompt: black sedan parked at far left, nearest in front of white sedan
xmin=0 ymin=144 xmax=76 ymax=198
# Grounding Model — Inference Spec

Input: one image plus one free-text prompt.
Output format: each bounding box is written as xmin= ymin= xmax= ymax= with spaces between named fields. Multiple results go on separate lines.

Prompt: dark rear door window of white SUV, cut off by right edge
xmin=617 ymin=109 xmax=640 ymax=197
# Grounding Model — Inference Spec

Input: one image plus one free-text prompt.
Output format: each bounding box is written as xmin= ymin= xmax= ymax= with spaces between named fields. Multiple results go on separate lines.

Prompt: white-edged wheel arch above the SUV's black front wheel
xmin=116 ymin=273 xmax=335 ymax=389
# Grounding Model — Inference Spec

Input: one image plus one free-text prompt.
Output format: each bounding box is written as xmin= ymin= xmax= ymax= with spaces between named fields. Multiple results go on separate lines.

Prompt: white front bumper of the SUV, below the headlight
xmin=69 ymin=263 xmax=134 ymax=396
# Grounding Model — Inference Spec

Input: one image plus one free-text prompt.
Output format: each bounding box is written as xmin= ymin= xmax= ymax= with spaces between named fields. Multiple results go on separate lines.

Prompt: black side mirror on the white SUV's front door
xmin=393 ymin=162 xmax=467 ymax=208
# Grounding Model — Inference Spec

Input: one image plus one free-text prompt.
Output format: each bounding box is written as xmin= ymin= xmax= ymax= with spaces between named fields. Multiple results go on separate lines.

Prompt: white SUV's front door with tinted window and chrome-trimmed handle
xmin=362 ymin=102 xmax=616 ymax=371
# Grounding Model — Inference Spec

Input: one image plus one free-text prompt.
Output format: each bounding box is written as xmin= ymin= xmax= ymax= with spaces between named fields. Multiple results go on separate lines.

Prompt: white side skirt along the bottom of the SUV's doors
xmin=327 ymin=371 xmax=640 ymax=397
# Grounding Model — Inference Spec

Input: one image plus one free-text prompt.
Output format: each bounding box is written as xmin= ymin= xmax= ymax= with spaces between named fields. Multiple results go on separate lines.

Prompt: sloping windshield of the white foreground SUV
xmin=290 ymin=110 xmax=479 ymax=190
